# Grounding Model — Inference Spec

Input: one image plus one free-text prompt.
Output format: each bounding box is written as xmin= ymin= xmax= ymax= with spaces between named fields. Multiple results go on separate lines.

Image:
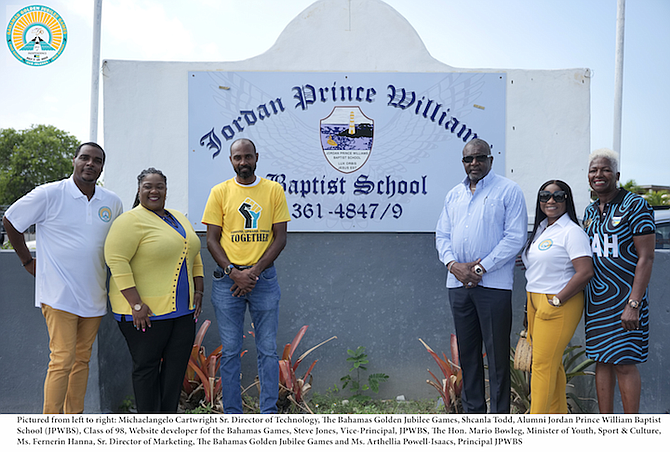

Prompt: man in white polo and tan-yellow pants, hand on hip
xmin=2 ymin=143 xmax=123 ymax=414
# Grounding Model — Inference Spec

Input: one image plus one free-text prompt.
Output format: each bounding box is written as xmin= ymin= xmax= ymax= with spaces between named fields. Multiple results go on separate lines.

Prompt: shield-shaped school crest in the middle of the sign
xmin=320 ymin=107 xmax=375 ymax=174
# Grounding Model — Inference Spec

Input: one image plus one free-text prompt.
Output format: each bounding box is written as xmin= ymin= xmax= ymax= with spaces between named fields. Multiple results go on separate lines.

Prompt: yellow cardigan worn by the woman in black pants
xmin=105 ymin=205 xmax=204 ymax=315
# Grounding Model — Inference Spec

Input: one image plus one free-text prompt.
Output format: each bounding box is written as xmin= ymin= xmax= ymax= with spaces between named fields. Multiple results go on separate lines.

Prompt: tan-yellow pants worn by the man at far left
xmin=42 ymin=304 xmax=102 ymax=414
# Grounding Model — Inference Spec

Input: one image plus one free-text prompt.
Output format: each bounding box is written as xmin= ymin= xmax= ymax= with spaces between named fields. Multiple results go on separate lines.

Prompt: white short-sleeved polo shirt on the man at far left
xmin=5 ymin=177 xmax=123 ymax=317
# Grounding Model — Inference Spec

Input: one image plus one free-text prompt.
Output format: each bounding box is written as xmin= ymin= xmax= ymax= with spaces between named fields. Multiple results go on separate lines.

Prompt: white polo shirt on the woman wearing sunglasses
xmin=521 ymin=213 xmax=591 ymax=294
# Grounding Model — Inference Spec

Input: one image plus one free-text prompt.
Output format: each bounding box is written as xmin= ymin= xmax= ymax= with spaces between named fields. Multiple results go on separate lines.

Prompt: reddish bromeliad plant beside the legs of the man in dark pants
xmin=419 ymin=334 xmax=463 ymax=413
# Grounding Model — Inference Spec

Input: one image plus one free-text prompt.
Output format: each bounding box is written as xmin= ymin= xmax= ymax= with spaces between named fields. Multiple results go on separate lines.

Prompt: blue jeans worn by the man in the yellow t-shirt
xmin=212 ymin=266 xmax=281 ymax=414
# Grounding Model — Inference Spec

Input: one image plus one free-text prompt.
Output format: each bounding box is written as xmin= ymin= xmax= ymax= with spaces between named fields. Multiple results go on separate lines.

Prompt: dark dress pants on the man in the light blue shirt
xmin=449 ymin=286 xmax=512 ymax=413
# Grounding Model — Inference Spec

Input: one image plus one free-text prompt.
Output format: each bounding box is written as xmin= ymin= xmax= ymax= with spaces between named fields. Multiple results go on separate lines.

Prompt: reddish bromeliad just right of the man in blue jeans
xmin=278 ymin=325 xmax=337 ymax=414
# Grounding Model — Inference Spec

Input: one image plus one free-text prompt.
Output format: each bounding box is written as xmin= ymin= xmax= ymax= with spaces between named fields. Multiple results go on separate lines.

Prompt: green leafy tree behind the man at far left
xmin=0 ymin=125 xmax=80 ymax=204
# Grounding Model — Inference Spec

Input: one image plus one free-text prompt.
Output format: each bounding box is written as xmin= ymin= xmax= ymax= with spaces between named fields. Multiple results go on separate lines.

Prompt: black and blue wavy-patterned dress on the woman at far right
xmin=584 ymin=189 xmax=656 ymax=364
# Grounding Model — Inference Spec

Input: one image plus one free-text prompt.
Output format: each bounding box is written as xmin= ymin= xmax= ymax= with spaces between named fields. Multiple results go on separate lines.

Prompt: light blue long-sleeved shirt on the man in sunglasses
xmin=435 ymin=171 xmax=528 ymax=290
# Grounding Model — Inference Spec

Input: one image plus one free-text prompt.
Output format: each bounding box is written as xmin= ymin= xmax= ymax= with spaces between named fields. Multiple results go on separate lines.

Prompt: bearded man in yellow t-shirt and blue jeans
xmin=202 ymin=138 xmax=291 ymax=413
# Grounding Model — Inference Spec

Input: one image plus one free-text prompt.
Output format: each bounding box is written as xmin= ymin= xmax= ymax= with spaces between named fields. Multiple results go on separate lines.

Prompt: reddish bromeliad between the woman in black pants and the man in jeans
xmin=182 ymin=320 xmax=223 ymax=411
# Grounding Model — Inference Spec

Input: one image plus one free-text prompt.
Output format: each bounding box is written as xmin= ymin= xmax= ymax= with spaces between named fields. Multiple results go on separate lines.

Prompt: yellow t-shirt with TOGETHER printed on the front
xmin=202 ymin=177 xmax=291 ymax=265
